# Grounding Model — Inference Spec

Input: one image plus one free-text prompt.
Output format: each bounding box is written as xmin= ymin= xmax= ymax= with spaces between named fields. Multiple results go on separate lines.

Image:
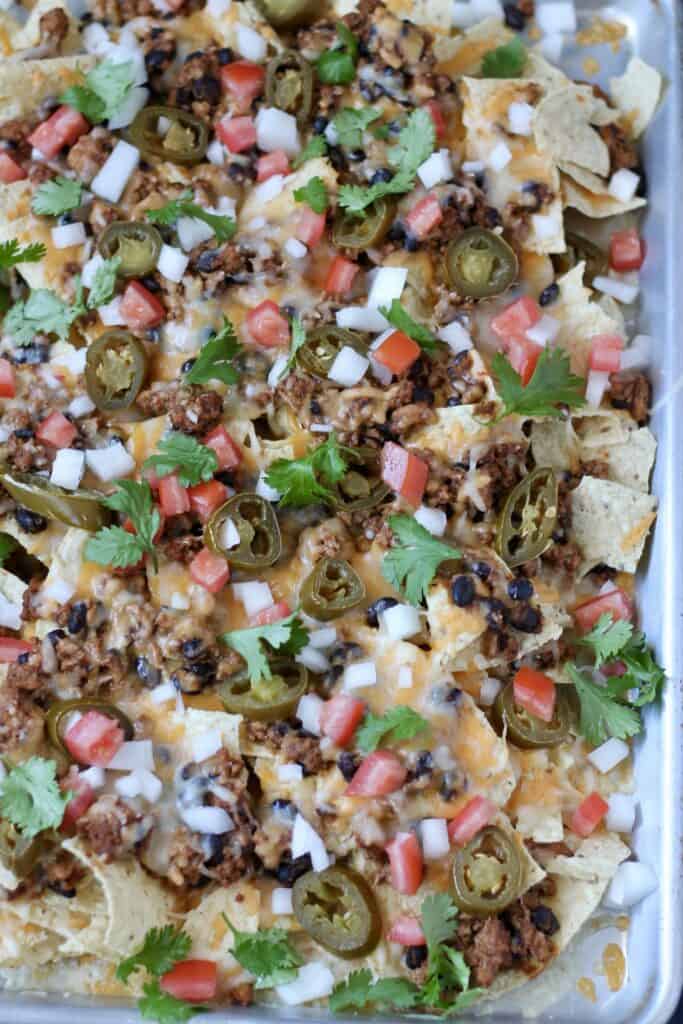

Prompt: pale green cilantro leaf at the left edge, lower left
xmin=0 ymin=757 xmax=71 ymax=839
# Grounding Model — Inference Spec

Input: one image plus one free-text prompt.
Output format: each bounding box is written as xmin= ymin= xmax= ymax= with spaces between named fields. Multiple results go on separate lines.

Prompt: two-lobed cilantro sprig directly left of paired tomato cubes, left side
xmin=85 ymin=480 xmax=161 ymax=569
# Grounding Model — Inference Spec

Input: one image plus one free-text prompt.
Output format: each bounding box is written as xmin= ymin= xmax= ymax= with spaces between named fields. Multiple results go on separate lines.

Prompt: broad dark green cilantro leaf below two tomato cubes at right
xmin=492 ymin=348 xmax=586 ymax=422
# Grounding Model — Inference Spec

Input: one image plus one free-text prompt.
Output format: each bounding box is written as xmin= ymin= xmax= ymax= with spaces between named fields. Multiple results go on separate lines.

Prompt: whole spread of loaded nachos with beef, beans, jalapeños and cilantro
xmin=0 ymin=0 xmax=664 ymax=1022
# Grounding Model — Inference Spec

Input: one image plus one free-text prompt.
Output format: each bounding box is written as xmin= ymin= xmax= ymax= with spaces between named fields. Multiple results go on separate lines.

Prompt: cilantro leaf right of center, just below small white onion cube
xmin=382 ymin=515 xmax=460 ymax=605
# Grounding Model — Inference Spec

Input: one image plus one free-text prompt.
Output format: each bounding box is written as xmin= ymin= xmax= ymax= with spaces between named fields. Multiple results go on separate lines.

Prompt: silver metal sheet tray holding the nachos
xmin=0 ymin=0 xmax=683 ymax=1024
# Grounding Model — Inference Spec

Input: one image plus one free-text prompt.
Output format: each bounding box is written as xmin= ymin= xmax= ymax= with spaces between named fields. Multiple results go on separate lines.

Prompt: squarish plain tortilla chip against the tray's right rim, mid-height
xmin=571 ymin=476 xmax=657 ymax=573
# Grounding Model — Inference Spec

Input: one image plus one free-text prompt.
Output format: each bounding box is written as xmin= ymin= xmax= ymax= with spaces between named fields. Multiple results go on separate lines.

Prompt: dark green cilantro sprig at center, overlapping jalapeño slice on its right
xmin=265 ymin=433 xmax=353 ymax=506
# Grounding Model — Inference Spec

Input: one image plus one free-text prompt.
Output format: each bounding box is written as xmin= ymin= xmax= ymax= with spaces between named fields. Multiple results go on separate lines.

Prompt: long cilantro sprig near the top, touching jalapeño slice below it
xmin=339 ymin=108 xmax=436 ymax=216
